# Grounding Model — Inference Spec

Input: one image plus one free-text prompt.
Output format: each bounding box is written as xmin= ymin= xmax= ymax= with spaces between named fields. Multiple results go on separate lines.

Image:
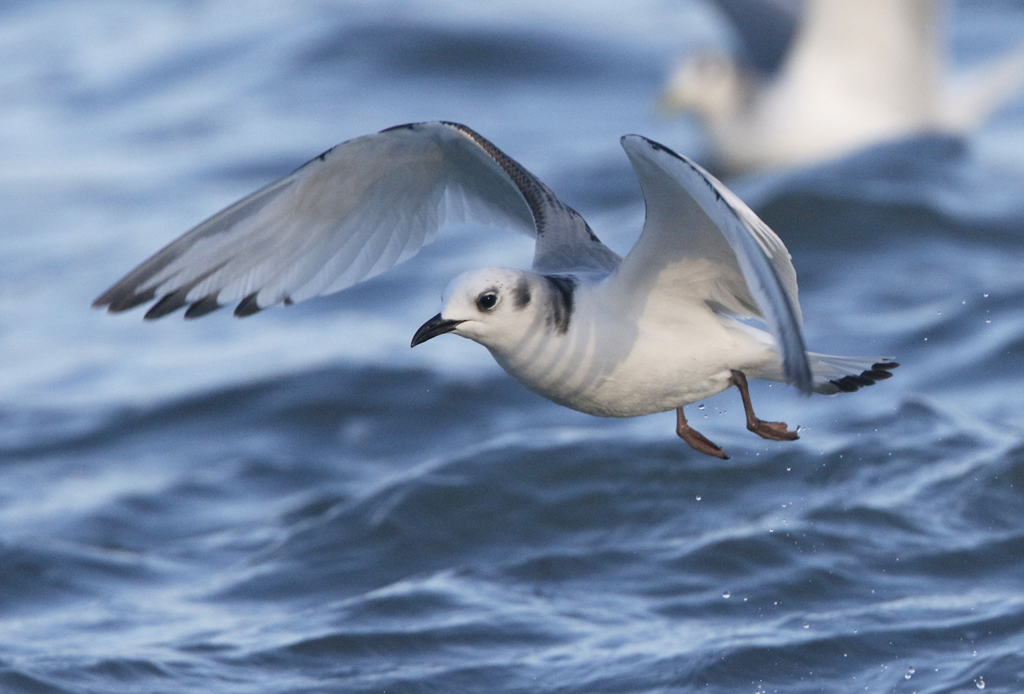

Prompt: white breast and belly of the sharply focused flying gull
xmin=490 ymin=284 xmax=779 ymax=417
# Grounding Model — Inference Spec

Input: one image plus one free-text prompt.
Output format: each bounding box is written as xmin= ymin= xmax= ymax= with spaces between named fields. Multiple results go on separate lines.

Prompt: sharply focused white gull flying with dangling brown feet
xmin=93 ymin=122 xmax=898 ymax=458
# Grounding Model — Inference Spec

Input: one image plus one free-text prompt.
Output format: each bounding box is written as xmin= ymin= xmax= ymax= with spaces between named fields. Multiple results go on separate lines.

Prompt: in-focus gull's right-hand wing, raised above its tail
xmin=611 ymin=135 xmax=812 ymax=393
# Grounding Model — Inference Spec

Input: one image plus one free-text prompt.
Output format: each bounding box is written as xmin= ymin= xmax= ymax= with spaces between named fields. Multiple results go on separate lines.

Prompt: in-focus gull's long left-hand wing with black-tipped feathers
xmin=93 ymin=123 xmax=620 ymax=318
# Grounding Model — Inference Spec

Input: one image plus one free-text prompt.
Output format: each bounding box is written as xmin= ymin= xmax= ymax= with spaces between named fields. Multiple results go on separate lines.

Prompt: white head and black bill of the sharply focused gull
xmin=412 ymin=267 xmax=542 ymax=350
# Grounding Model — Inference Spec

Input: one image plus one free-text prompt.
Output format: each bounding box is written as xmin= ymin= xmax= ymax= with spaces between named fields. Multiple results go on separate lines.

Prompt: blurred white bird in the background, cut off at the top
xmin=660 ymin=0 xmax=1024 ymax=173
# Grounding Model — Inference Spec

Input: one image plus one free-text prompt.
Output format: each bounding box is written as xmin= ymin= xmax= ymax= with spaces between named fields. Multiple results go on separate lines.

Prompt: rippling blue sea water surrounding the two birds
xmin=6 ymin=0 xmax=1024 ymax=694
